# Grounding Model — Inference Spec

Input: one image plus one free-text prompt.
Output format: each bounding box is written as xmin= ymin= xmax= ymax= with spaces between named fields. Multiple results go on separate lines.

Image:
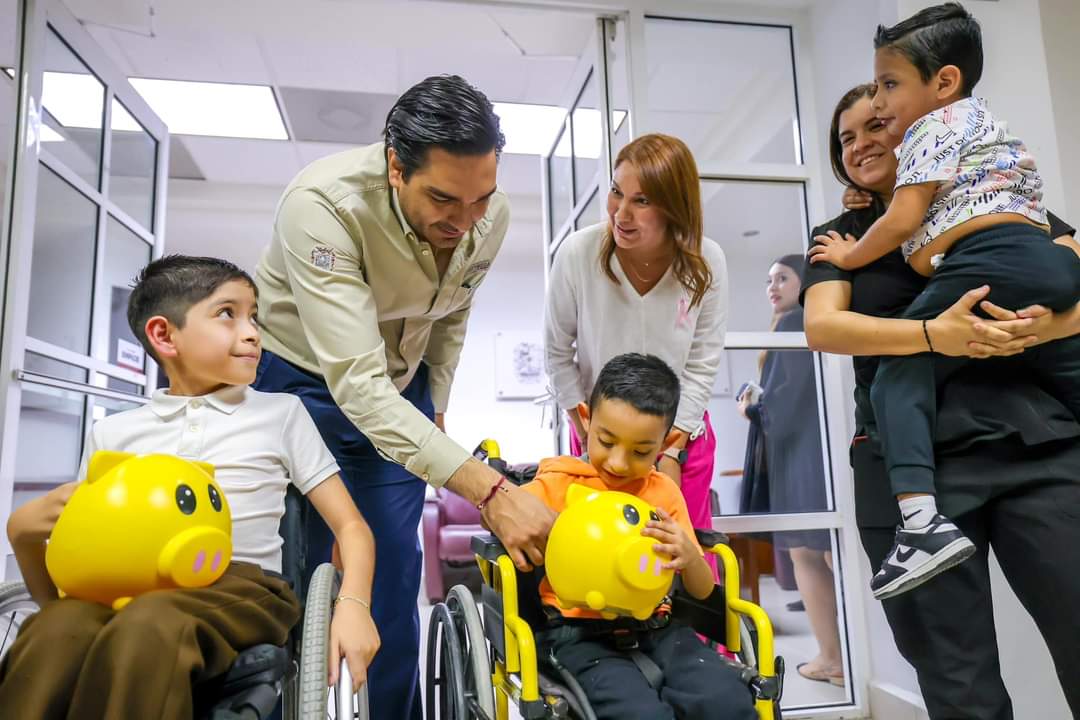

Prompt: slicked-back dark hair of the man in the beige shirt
xmin=382 ymin=74 xmax=507 ymax=181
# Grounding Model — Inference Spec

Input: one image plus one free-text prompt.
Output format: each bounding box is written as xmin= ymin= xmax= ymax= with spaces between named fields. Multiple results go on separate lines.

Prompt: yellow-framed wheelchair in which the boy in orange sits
xmin=426 ymin=440 xmax=784 ymax=720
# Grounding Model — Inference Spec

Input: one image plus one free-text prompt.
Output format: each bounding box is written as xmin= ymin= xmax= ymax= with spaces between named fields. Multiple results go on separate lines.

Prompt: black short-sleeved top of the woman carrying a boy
xmin=799 ymin=205 xmax=1080 ymax=524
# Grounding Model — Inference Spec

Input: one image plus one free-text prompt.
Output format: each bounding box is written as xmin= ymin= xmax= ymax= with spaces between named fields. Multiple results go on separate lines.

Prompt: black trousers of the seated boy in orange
xmin=539 ymin=622 xmax=757 ymax=720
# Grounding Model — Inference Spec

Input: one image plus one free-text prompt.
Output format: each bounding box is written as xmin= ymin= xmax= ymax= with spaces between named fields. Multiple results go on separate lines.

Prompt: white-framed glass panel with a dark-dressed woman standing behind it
xmin=633 ymin=15 xmax=865 ymax=718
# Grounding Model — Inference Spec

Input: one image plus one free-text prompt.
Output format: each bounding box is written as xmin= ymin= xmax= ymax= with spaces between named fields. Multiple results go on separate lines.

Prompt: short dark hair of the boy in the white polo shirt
xmin=127 ymin=255 xmax=258 ymax=362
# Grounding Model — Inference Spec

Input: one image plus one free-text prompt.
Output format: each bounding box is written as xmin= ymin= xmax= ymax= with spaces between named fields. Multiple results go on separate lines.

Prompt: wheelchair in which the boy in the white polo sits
xmin=0 ymin=486 xmax=367 ymax=720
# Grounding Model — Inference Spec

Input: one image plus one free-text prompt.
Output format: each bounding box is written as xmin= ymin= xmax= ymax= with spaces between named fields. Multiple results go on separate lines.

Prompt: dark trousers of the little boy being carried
xmin=870 ymin=225 xmax=1080 ymax=496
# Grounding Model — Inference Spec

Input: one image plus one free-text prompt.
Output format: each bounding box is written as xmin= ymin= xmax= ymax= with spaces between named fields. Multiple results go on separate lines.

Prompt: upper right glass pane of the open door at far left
xmin=109 ymin=99 xmax=158 ymax=231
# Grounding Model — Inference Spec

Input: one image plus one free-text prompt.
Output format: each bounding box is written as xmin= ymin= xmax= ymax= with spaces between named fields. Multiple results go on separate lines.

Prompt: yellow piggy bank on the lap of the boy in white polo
xmin=45 ymin=451 xmax=232 ymax=610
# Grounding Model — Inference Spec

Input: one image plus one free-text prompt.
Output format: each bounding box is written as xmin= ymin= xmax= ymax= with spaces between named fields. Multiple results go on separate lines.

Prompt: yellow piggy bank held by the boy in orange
xmin=544 ymin=485 xmax=675 ymax=620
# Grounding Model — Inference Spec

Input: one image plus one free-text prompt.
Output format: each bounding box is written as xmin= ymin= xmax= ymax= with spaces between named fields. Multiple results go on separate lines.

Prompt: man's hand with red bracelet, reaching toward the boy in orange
xmin=446 ymin=459 xmax=555 ymax=572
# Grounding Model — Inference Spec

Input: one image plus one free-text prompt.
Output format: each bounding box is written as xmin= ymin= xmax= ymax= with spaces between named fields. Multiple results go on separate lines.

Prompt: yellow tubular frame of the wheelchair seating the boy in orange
xmin=473 ymin=538 xmax=783 ymax=720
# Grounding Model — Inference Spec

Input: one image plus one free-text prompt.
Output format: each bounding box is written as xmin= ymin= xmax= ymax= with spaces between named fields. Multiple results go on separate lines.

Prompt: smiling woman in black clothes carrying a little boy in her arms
xmin=804 ymin=84 xmax=1080 ymax=720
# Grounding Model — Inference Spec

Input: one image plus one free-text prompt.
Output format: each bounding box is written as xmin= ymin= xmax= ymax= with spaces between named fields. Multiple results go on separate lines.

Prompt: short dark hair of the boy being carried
xmin=874 ymin=2 xmax=983 ymax=97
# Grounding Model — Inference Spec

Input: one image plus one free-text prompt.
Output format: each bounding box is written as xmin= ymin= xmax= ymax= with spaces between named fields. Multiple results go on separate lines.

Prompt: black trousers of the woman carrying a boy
xmin=852 ymin=439 xmax=1080 ymax=720
